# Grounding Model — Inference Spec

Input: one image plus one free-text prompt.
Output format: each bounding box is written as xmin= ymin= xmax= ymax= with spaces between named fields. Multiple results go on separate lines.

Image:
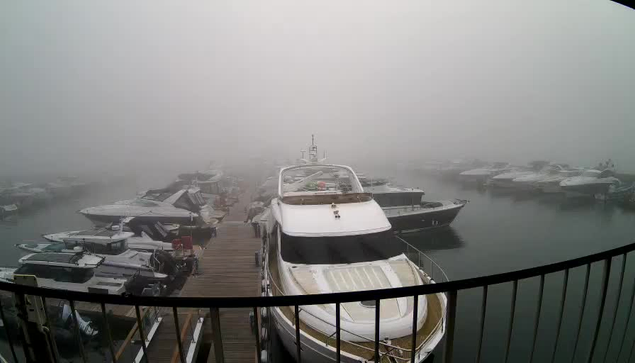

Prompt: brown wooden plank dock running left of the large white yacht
xmin=143 ymin=194 xmax=261 ymax=363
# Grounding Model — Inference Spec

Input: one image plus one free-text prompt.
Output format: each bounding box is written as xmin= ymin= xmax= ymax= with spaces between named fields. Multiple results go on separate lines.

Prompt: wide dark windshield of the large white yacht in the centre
xmin=280 ymin=230 xmax=403 ymax=265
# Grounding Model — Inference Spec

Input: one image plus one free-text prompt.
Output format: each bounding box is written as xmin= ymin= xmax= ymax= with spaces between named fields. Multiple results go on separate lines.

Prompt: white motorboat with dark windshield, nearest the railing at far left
xmin=0 ymin=253 xmax=128 ymax=295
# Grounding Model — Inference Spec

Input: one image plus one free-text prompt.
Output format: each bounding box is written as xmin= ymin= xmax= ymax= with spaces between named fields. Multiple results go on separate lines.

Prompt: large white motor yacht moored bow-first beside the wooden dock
xmin=263 ymin=164 xmax=447 ymax=362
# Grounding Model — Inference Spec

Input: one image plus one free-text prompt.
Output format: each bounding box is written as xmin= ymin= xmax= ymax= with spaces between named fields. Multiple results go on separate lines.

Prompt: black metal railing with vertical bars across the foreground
xmin=0 ymin=243 xmax=635 ymax=363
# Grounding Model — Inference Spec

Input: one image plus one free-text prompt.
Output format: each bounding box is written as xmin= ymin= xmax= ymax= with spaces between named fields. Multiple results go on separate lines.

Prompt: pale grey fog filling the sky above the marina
xmin=0 ymin=0 xmax=635 ymax=181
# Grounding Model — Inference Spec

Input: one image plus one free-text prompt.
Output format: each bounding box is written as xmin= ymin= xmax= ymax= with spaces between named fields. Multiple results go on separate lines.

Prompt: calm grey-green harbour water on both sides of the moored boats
xmin=0 ymin=170 xmax=635 ymax=362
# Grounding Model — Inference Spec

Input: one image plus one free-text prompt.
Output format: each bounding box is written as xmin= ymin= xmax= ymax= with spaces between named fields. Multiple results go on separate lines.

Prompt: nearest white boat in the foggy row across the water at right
xmin=560 ymin=169 xmax=621 ymax=196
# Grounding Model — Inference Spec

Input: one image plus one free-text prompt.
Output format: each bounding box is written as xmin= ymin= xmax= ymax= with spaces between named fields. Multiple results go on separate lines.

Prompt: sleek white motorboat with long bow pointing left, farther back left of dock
xmin=79 ymin=198 xmax=199 ymax=225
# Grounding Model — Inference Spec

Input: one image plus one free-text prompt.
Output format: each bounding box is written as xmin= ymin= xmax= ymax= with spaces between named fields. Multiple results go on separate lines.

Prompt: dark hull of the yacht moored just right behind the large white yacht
xmin=384 ymin=202 xmax=465 ymax=233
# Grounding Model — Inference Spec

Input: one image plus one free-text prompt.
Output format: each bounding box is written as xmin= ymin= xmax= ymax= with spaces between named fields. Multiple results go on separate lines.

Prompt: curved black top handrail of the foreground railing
xmin=0 ymin=243 xmax=635 ymax=308
